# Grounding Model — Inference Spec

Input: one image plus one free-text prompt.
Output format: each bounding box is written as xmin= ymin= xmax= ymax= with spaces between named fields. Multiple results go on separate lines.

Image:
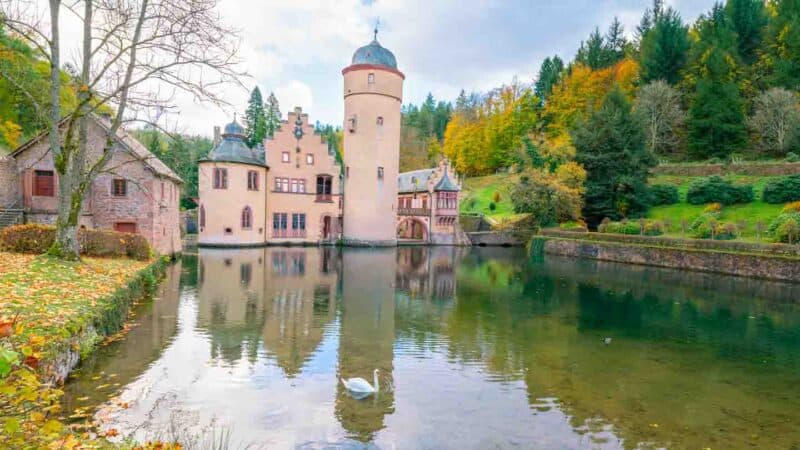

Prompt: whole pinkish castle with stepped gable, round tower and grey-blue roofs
xmin=198 ymin=31 xmax=461 ymax=247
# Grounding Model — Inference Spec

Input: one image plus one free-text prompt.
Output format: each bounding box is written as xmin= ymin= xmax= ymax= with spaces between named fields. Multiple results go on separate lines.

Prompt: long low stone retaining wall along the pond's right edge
xmin=538 ymin=238 xmax=800 ymax=281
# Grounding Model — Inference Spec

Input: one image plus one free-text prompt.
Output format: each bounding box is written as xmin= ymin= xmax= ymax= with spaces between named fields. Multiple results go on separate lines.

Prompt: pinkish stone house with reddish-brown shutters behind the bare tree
xmin=0 ymin=115 xmax=183 ymax=255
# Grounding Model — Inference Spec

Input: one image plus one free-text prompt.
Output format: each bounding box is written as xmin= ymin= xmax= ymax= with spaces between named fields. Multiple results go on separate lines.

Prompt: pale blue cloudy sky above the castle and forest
xmin=64 ymin=0 xmax=714 ymax=135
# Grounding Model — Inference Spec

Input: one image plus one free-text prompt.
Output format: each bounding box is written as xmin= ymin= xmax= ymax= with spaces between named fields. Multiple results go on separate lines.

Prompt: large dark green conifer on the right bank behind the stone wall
xmin=572 ymin=87 xmax=656 ymax=227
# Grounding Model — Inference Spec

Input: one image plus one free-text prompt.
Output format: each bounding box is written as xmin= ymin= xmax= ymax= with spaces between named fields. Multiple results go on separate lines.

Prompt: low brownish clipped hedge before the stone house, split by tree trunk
xmin=0 ymin=224 xmax=151 ymax=260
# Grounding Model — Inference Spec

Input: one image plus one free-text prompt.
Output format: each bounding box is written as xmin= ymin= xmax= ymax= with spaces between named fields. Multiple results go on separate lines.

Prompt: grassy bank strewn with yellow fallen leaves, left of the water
xmin=0 ymin=252 xmax=166 ymax=448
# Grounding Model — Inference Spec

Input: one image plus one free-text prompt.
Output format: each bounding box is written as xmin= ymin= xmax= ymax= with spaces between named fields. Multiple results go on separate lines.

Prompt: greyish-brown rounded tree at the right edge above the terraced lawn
xmin=749 ymin=88 xmax=800 ymax=156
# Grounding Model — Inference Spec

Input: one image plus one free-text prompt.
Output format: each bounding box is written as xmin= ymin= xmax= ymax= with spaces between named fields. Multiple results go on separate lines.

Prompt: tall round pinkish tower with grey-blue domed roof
xmin=342 ymin=30 xmax=405 ymax=246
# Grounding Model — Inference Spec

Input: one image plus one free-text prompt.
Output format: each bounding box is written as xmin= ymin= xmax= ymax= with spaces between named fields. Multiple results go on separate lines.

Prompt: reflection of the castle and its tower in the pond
xmin=196 ymin=247 xmax=464 ymax=439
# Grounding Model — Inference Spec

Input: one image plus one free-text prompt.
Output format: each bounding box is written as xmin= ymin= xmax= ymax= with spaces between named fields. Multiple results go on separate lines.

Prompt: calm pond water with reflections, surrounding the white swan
xmin=64 ymin=248 xmax=800 ymax=449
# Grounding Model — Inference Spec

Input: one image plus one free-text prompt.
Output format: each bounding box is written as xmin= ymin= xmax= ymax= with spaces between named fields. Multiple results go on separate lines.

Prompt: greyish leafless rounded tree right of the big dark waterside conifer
xmin=634 ymin=80 xmax=684 ymax=155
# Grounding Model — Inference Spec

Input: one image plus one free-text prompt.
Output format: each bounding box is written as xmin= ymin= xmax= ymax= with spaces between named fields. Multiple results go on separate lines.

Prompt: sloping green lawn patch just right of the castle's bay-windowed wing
xmin=459 ymin=173 xmax=519 ymax=221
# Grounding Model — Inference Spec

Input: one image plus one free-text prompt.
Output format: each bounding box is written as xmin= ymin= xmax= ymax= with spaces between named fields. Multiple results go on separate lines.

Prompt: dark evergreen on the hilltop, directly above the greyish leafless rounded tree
xmin=638 ymin=0 xmax=689 ymax=85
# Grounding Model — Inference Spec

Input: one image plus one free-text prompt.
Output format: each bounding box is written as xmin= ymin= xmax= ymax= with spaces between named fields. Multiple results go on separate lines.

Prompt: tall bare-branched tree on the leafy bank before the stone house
xmin=0 ymin=0 xmax=246 ymax=259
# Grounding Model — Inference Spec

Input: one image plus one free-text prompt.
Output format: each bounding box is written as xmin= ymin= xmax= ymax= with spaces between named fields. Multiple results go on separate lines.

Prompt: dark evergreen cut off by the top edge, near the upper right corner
xmin=725 ymin=0 xmax=767 ymax=65
